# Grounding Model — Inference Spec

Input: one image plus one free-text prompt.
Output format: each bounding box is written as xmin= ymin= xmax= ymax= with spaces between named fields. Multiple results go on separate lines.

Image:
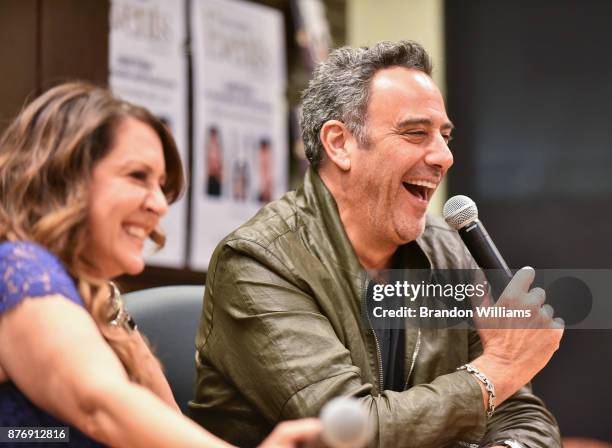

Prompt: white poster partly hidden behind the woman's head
xmin=109 ymin=0 xmax=188 ymax=267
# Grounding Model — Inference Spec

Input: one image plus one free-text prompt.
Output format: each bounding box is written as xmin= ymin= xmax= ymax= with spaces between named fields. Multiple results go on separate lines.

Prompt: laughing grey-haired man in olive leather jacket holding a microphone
xmin=191 ymin=42 xmax=562 ymax=448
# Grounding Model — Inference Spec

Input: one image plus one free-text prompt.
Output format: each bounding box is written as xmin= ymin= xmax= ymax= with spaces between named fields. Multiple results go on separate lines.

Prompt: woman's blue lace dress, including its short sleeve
xmin=0 ymin=241 xmax=103 ymax=448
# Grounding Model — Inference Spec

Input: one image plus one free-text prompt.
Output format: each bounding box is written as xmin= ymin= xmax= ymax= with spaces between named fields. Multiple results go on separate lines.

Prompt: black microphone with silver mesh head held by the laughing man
xmin=442 ymin=195 xmax=512 ymax=298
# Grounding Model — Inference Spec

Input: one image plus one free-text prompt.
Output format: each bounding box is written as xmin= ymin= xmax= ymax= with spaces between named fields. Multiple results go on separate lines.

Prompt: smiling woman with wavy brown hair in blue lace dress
xmin=0 ymin=83 xmax=319 ymax=447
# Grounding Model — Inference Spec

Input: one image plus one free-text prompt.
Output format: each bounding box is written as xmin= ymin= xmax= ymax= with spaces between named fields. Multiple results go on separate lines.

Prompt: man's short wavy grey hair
xmin=300 ymin=40 xmax=431 ymax=170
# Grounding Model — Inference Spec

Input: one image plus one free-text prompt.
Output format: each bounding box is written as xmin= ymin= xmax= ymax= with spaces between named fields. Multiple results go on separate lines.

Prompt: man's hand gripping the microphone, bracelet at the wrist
xmin=471 ymin=268 xmax=564 ymax=406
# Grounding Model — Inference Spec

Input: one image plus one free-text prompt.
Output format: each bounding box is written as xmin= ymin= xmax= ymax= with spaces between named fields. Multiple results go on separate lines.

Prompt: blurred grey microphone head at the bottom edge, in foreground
xmin=320 ymin=397 xmax=372 ymax=448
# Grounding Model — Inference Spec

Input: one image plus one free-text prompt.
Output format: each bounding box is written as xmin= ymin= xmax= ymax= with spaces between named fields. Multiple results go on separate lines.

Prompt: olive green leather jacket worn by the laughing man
xmin=190 ymin=170 xmax=561 ymax=448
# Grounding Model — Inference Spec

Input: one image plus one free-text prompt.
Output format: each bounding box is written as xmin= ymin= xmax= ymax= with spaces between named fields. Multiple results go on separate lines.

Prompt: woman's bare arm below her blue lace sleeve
xmin=0 ymin=296 xmax=229 ymax=448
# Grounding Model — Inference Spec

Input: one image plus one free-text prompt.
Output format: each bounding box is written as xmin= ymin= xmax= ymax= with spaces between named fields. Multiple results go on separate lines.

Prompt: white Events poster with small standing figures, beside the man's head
xmin=190 ymin=0 xmax=288 ymax=269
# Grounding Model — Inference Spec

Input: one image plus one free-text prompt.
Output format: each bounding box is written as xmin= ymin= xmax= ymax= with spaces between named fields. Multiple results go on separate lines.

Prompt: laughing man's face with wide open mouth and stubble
xmin=346 ymin=67 xmax=453 ymax=246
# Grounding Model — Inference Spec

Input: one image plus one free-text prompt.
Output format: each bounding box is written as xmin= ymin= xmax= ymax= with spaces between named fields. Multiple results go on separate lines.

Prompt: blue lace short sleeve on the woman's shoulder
xmin=0 ymin=241 xmax=84 ymax=313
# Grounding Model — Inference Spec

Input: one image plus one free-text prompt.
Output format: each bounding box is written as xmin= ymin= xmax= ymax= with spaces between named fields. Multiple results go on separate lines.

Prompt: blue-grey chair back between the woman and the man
xmin=123 ymin=285 xmax=204 ymax=415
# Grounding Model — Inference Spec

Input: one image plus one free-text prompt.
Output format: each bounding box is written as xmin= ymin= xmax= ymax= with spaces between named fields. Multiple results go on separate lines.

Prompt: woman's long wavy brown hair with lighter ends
xmin=0 ymin=82 xmax=185 ymax=385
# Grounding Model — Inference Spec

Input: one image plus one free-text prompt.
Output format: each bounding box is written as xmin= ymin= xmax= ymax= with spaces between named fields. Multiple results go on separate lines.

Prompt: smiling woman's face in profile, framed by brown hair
xmin=86 ymin=118 xmax=168 ymax=278
